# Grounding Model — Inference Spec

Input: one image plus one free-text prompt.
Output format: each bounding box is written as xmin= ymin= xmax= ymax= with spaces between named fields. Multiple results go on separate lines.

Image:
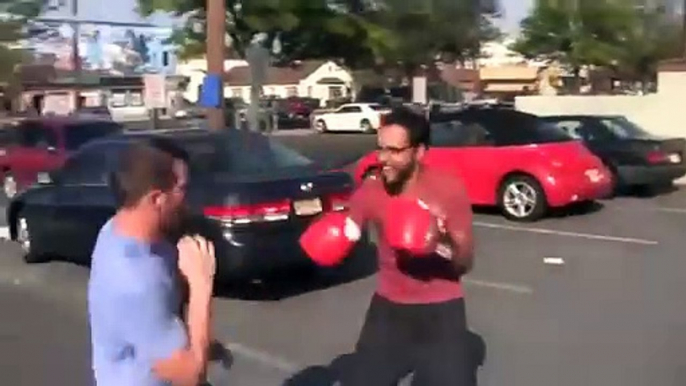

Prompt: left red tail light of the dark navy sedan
xmin=203 ymin=200 xmax=291 ymax=224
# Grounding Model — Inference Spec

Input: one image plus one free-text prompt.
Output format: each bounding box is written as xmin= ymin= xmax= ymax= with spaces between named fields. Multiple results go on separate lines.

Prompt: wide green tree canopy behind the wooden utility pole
xmin=138 ymin=0 xmax=506 ymax=73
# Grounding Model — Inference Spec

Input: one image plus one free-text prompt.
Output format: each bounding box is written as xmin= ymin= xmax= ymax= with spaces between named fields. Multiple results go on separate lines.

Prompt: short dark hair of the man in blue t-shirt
xmin=110 ymin=137 xmax=189 ymax=207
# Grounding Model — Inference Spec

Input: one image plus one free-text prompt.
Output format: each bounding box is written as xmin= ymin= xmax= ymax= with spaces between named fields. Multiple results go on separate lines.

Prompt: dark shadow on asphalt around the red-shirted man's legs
xmin=282 ymin=331 xmax=486 ymax=386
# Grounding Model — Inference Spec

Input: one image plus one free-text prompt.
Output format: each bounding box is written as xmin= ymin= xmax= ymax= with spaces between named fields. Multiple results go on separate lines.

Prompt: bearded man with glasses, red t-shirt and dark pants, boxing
xmin=342 ymin=108 xmax=473 ymax=386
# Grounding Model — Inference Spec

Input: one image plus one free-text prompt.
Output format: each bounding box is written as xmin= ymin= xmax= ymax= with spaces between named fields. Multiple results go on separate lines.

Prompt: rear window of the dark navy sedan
xmin=187 ymin=135 xmax=315 ymax=176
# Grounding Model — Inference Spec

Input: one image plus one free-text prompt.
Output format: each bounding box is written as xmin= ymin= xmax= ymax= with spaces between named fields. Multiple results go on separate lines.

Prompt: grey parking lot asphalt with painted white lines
xmin=0 ymin=131 xmax=686 ymax=386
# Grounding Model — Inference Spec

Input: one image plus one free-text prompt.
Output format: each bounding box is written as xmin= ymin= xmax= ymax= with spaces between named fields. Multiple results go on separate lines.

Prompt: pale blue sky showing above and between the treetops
xmin=41 ymin=0 xmax=533 ymax=32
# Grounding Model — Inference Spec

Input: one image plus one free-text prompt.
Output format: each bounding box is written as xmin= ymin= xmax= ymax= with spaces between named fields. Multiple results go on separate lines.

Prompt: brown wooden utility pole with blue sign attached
xmin=206 ymin=0 xmax=226 ymax=130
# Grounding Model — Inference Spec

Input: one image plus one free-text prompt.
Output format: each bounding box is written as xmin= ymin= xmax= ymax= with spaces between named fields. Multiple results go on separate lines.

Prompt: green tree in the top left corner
xmin=0 ymin=0 xmax=43 ymax=84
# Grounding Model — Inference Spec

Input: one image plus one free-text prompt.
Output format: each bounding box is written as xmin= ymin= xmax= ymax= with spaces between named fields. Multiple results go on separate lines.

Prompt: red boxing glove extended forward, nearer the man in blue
xmin=300 ymin=212 xmax=362 ymax=267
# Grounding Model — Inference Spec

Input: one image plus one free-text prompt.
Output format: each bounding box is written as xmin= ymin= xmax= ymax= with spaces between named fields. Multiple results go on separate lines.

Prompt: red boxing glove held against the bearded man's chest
xmin=383 ymin=197 xmax=439 ymax=256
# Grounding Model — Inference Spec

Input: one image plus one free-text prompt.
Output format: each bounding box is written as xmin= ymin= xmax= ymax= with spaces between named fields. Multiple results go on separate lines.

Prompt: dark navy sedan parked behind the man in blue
xmin=7 ymin=130 xmax=353 ymax=279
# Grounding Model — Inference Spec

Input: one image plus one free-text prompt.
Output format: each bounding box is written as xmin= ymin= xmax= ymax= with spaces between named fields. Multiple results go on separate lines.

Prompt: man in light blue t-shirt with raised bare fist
xmin=88 ymin=139 xmax=215 ymax=386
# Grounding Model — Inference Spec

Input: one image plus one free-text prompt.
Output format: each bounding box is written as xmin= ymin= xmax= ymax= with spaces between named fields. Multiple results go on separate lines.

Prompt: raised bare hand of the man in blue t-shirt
xmin=176 ymin=236 xmax=216 ymax=291
